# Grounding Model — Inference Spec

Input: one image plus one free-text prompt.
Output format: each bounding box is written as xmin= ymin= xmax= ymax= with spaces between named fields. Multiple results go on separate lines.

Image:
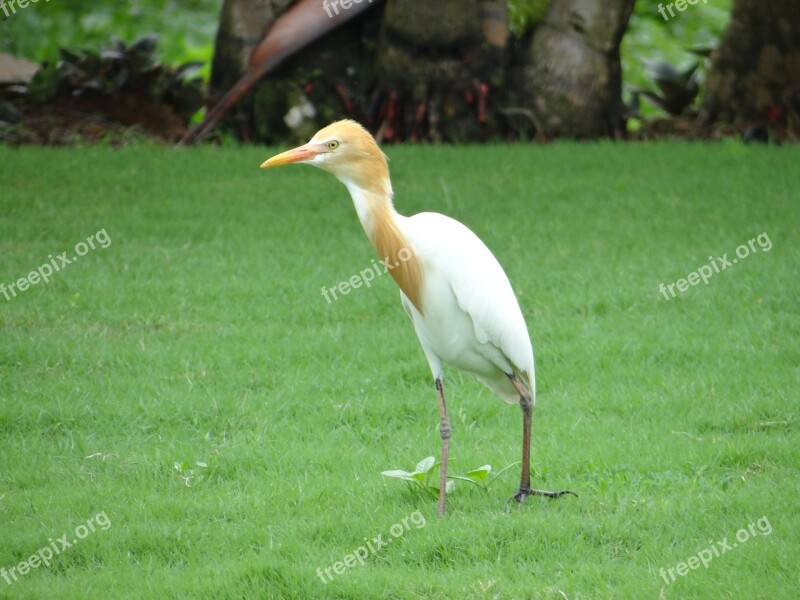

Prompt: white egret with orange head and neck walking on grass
xmin=261 ymin=119 xmax=574 ymax=516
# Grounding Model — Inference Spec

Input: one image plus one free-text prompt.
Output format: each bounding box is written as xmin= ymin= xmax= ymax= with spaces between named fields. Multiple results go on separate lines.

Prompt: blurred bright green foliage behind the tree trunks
xmin=0 ymin=0 xmax=731 ymax=120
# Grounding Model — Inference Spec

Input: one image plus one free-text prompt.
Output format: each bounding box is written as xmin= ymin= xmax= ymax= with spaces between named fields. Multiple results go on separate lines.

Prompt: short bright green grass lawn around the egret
xmin=0 ymin=143 xmax=800 ymax=600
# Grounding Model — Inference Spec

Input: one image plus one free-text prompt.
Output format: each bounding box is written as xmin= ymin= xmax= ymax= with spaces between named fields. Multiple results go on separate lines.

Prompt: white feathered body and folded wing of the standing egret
xmin=397 ymin=213 xmax=535 ymax=402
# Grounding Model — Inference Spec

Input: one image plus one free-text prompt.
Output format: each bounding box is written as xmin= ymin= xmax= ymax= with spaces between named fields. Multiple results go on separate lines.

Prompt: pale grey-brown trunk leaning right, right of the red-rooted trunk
xmin=512 ymin=0 xmax=634 ymax=138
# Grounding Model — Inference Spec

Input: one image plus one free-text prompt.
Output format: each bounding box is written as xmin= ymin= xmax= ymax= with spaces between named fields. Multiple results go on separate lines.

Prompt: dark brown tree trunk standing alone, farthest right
xmin=701 ymin=0 xmax=800 ymax=133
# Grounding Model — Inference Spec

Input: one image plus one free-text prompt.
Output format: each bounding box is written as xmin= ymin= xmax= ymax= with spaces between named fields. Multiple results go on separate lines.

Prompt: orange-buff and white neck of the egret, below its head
xmin=343 ymin=178 xmax=423 ymax=313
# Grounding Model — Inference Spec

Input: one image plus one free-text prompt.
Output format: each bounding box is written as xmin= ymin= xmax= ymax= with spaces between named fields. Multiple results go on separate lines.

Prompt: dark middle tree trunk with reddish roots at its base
xmin=371 ymin=0 xmax=509 ymax=142
